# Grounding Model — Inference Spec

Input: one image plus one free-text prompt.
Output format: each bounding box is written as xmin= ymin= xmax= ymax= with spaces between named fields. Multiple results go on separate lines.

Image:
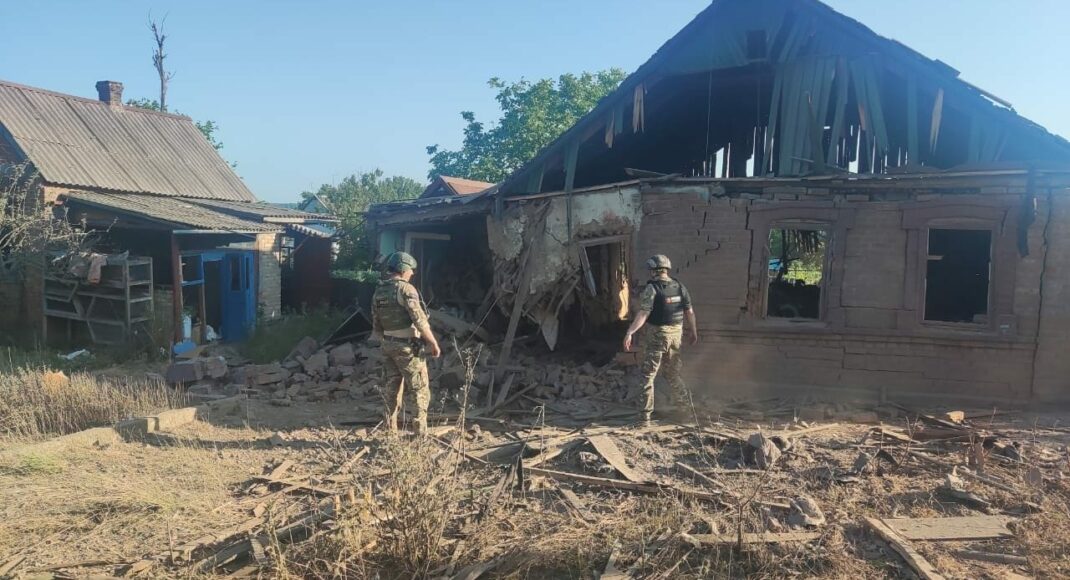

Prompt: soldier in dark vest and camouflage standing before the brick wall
xmin=624 ymin=254 xmax=699 ymax=422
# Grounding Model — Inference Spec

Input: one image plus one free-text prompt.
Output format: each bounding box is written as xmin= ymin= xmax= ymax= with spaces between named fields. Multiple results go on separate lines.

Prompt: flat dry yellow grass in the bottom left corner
xmin=0 ymin=425 xmax=276 ymax=571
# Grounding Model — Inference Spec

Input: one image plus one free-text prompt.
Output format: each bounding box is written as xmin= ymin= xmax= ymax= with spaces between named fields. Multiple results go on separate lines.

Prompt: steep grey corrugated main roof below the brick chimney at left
xmin=0 ymin=80 xmax=256 ymax=201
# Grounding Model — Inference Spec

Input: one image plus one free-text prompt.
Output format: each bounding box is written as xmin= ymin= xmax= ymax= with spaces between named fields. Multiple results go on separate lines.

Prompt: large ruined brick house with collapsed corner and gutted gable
xmin=369 ymin=0 xmax=1070 ymax=401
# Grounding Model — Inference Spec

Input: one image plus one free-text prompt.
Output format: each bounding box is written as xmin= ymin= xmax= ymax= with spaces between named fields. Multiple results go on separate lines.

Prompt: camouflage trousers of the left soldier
xmin=381 ymin=338 xmax=431 ymax=433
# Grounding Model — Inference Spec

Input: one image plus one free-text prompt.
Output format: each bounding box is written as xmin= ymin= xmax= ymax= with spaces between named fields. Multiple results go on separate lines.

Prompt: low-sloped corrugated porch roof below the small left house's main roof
xmin=60 ymin=192 xmax=282 ymax=233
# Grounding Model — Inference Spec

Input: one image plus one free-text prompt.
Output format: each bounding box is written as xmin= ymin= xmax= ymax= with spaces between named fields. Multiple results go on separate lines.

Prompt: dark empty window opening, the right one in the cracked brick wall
xmin=924 ymin=228 xmax=992 ymax=323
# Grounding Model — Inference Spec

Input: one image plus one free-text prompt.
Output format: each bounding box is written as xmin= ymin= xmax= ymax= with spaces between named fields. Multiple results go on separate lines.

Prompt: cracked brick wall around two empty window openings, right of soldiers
xmin=635 ymin=181 xmax=1070 ymax=401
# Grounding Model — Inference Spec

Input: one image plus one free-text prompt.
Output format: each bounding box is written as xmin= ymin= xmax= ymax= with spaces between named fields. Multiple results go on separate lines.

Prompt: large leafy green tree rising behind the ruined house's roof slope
xmin=427 ymin=68 xmax=626 ymax=183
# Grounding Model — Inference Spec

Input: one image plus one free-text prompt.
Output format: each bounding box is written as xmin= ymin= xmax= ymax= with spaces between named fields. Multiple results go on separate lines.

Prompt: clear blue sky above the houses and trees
xmin=0 ymin=0 xmax=1070 ymax=201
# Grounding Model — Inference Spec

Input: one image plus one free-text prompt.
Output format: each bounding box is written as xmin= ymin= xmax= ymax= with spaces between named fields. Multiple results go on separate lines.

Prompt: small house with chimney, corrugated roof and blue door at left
xmin=0 ymin=81 xmax=335 ymax=345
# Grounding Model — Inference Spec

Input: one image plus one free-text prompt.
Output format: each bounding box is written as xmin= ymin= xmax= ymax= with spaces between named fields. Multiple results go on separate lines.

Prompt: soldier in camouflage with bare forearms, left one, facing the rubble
xmin=371 ymin=251 xmax=442 ymax=434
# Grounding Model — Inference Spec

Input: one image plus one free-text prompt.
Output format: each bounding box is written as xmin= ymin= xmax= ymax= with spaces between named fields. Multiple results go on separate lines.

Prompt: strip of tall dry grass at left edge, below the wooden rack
xmin=0 ymin=369 xmax=185 ymax=440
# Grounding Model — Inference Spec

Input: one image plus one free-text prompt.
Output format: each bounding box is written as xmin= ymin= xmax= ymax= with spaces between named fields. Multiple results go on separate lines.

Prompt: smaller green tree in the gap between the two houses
xmin=301 ymin=169 xmax=424 ymax=270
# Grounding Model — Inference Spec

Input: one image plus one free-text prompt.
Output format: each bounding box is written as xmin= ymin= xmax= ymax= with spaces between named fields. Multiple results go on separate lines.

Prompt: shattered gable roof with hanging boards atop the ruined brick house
xmin=500 ymin=0 xmax=1070 ymax=195
